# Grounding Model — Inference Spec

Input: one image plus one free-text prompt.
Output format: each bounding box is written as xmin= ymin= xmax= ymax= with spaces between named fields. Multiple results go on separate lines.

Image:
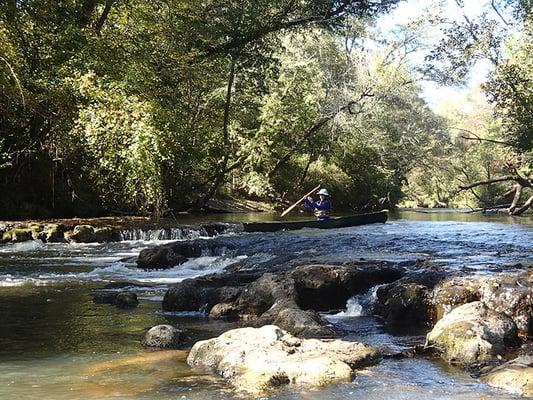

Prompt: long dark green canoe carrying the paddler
xmin=243 ymin=210 xmax=388 ymax=232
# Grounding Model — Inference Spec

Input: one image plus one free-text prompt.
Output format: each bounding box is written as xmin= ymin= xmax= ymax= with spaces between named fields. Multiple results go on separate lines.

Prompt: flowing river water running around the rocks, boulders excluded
xmin=0 ymin=212 xmax=533 ymax=400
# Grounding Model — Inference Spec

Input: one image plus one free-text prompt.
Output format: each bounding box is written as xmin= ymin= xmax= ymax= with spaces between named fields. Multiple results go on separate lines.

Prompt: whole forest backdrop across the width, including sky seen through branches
xmin=0 ymin=0 xmax=533 ymax=218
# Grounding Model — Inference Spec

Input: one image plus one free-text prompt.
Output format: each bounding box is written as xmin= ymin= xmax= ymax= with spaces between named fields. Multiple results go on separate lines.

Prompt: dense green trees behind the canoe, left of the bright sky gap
xmin=0 ymin=0 xmax=470 ymax=215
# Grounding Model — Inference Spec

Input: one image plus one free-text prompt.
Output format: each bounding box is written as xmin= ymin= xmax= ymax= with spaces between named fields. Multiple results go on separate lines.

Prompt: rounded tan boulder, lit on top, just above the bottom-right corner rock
xmin=426 ymin=301 xmax=517 ymax=365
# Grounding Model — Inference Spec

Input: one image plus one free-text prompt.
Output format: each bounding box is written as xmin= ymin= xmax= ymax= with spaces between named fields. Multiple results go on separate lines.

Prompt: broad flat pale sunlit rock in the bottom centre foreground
xmin=187 ymin=325 xmax=379 ymax=394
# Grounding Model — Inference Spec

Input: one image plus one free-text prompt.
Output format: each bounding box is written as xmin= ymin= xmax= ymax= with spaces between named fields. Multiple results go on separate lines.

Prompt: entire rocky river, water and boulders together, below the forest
xmin=0 ymin=211 xmax=533 ymax=400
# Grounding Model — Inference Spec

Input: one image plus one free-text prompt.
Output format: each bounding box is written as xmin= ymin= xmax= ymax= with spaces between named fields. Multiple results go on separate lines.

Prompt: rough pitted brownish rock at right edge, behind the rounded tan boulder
xmin=479 ymin=271 xmax=533 ymax=335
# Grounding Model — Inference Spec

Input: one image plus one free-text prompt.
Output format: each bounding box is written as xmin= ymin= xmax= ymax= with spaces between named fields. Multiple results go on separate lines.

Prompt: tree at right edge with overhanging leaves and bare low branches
xmin=422 ymin=0 xmax=533 ymax=215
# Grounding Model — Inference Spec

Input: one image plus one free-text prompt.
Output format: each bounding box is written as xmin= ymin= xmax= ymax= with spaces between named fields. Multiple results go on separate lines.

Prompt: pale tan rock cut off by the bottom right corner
xmin=481 ymin=355 xmax=533 ymax=397
